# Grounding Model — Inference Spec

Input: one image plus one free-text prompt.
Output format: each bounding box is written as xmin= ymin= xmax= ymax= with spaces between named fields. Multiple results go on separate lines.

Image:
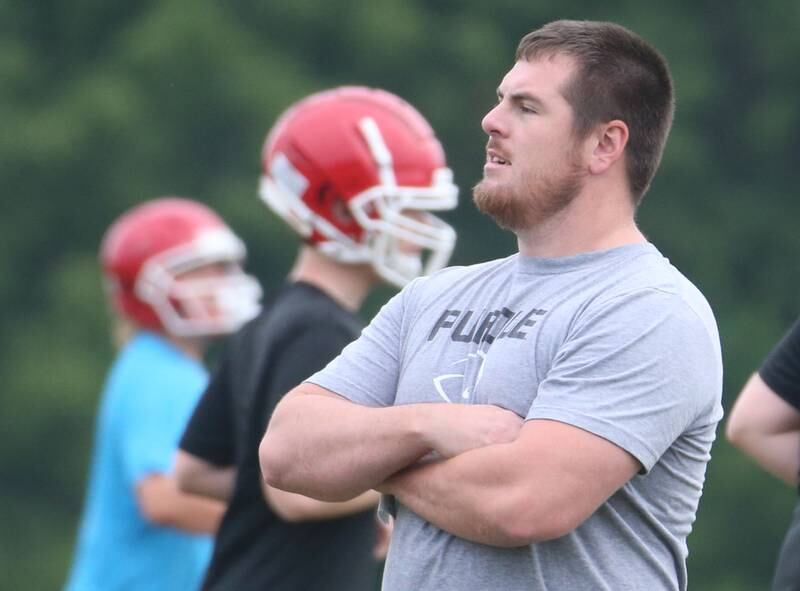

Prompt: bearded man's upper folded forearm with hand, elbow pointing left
xmin=259 ymin=383 xmax=521 ymax=501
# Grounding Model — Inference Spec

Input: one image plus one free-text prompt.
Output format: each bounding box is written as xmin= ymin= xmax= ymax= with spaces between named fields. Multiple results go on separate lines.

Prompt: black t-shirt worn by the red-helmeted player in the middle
xmin=180 ymin=283 xmax=379 ymax=591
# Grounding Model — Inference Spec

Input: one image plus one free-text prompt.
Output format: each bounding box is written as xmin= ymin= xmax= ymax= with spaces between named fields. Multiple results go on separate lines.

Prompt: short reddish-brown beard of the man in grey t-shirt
xmin=472 ymin=152 xmax=584 ymax=232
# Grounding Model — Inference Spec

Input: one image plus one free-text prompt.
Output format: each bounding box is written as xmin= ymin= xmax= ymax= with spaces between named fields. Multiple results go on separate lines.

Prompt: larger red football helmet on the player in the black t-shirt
xmin=260 ymin=86 xmax=458 ymax=286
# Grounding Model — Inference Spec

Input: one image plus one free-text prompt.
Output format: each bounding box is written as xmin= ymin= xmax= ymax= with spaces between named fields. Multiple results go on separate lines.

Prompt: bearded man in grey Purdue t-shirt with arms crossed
xmin=260 ymin=21 xmax=722 ymax=591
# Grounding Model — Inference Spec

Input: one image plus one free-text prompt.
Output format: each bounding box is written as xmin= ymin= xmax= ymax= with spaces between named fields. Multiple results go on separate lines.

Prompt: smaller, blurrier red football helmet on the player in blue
xmin=100 ymin=197 xmax=261 ymax=336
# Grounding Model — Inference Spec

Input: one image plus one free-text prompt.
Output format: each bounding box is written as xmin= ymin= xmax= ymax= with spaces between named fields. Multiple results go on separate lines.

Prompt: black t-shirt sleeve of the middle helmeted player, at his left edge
xmin=179 ymin=345 xmax=235 ymax=466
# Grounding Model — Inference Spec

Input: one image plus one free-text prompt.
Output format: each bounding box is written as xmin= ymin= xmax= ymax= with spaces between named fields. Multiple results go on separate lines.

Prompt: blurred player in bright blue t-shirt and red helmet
xmin=66 ymin=197 xmax=261 ymax=591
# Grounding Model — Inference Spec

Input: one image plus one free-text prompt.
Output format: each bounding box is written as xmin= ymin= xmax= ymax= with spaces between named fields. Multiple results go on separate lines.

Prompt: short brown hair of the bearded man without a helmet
xmin=516 ymin=20 xmax=675 ymax=205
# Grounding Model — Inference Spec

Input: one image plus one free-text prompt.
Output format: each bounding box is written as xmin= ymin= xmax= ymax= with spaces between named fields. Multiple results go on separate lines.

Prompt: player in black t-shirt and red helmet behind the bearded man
xmin=176 ymin=87 xmax=458 ymax=591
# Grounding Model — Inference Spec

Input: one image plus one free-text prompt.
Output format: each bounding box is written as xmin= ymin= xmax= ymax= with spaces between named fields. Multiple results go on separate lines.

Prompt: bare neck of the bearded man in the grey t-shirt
xmin=516 ymin=184 xmax=647 ymax=257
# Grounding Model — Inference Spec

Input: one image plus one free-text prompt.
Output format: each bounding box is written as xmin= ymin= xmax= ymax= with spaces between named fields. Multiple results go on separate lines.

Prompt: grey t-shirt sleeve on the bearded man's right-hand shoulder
xmin=527 ymin=289 xmax=722 ymax=470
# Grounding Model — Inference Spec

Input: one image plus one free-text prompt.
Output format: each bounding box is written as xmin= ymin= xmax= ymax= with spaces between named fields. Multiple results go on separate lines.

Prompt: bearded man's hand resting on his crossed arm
xmin=426 ymin=404 xmax=524 ymax=458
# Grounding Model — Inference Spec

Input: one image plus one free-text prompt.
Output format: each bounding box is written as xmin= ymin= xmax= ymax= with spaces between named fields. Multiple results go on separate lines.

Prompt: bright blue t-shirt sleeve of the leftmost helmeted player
xmin=119 ymin=370 xmax=207 ymax=484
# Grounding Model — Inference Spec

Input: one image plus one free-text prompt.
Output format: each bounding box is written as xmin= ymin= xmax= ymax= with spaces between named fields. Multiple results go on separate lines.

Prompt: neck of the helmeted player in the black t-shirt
xmin=289 ymin=246 xmax=377 ymax=312
